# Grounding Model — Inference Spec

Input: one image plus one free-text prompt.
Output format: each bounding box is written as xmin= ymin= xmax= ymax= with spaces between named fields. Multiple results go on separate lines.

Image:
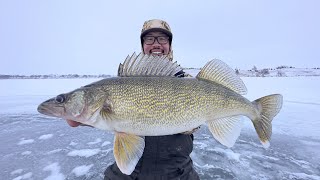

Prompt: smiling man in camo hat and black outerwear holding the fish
xmin=67 ymin=19 xmax=199 ymax=180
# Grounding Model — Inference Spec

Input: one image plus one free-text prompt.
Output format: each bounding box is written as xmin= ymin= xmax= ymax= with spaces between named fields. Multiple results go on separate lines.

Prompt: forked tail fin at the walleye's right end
xmin=252 ymin=94 xmax=283 ymax=148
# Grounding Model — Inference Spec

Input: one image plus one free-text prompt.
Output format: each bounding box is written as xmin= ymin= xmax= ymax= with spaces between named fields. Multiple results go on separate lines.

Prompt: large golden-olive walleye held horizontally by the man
xmin=38 ymin=54 xmax=282 ymax=175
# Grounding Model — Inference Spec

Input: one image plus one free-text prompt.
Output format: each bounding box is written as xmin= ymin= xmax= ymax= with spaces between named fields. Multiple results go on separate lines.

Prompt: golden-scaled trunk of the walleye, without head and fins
xmin=91 ymin=77 xmax=254 ymax=136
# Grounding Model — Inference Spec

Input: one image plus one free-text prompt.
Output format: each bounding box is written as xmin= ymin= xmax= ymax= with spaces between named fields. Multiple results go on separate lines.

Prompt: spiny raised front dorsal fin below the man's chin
xmin=118 ymin=53 xmax=182 ymax=77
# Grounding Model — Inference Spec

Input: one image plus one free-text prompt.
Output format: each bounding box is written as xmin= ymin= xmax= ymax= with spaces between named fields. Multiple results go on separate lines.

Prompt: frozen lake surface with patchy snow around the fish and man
xmin=0 ymin=77 xmax=320 ymax=180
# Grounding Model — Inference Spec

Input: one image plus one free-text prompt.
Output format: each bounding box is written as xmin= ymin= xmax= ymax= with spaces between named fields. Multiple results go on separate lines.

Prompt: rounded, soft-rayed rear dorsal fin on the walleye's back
xmin=197 ymin=59 xmax=247 ymax=95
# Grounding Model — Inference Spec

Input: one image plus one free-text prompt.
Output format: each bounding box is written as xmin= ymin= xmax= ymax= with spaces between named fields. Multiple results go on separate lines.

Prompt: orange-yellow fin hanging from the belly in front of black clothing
xmin=113 ymin=132 xmax=145 ymax=175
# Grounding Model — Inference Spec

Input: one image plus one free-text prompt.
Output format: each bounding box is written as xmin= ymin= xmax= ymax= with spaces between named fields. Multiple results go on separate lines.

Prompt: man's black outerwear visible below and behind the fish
xmin=104 ymin=71 xmax=199 ymax=180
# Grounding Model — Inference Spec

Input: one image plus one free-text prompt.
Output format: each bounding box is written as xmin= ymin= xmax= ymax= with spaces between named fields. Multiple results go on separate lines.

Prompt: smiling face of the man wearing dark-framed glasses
xmin=143 ymin=31 xmax=170 ymax=56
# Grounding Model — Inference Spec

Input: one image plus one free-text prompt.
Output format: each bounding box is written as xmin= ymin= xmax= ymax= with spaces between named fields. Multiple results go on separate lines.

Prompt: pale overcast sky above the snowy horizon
xmin=0 ymin=0 xmax=320 ymax=75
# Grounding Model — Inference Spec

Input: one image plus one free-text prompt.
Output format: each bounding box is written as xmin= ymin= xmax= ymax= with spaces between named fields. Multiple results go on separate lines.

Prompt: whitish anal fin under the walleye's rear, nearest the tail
xmin=207 ymin=116 xmax=243 ymax=148
